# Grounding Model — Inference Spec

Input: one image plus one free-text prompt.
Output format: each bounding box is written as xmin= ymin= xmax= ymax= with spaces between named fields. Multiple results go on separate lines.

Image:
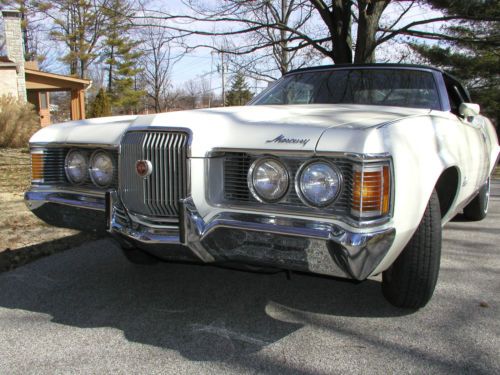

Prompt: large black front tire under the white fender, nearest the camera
xmin=382 ymin=190 xmax=441 ymax=309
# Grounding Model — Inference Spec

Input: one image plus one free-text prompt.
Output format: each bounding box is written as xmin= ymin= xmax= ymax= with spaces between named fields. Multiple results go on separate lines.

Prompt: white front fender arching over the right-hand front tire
xmin=374 ymin=116 xmax=464 ymax=274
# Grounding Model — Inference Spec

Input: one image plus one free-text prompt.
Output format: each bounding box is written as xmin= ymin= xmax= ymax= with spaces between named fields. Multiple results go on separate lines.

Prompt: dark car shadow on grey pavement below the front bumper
xmin=0 ymin=239 xmax=410 ymax=361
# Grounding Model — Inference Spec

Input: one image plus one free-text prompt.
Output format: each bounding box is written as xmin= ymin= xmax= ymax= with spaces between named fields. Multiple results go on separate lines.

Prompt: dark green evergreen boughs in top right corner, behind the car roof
xmin=412 ymin=0 xmax=500 ymax=129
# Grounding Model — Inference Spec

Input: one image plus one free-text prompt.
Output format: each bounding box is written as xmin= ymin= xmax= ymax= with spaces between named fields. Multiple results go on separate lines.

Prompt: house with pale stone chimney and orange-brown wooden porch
xmin=0 ymin=10 xmax=92 ymax=126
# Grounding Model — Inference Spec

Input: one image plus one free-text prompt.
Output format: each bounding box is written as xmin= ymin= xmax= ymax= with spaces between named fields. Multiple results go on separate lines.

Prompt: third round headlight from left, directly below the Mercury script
xmin=248 ymin=158 xmax=288 ymax=203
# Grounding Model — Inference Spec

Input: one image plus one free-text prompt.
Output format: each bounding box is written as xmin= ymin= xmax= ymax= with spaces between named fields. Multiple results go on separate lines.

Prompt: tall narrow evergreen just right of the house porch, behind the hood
xmin=105 ymin=0 xmax=145 ymax=113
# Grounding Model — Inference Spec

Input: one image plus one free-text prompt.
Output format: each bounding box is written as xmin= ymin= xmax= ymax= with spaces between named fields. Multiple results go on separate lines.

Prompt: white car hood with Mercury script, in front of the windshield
xmin=31 ymin=104 xmax=429 ymax=157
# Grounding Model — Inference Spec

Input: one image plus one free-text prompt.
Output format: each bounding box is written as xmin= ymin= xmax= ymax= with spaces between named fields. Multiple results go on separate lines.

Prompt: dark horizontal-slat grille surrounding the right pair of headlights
xmin=223 ymin=152 xmax=353 ymax=214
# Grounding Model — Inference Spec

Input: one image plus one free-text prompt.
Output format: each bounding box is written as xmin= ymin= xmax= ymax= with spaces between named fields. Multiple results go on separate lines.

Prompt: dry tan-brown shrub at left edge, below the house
xmin=0 ymin=95 xmax=40 ymax=147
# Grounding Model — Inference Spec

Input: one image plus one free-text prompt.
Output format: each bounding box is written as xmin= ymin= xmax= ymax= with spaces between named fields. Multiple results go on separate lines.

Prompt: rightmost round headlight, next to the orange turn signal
xmin=297 ymin=160 xmax=342 ymax=207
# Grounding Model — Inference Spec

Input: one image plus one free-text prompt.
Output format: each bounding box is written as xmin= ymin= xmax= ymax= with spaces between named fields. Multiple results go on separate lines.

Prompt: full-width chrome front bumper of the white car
xmin=25 ymin=192 xmax=396 ymax=280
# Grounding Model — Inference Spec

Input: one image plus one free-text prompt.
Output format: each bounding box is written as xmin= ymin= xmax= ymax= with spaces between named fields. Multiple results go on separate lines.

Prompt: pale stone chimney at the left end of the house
xmin=2 ymin=10 xmax=26 ymax=101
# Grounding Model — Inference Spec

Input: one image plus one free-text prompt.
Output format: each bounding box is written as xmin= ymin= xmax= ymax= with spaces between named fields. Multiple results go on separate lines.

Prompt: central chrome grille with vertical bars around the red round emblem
xmin=119 ymin=131 xmax=188 ymax=219
